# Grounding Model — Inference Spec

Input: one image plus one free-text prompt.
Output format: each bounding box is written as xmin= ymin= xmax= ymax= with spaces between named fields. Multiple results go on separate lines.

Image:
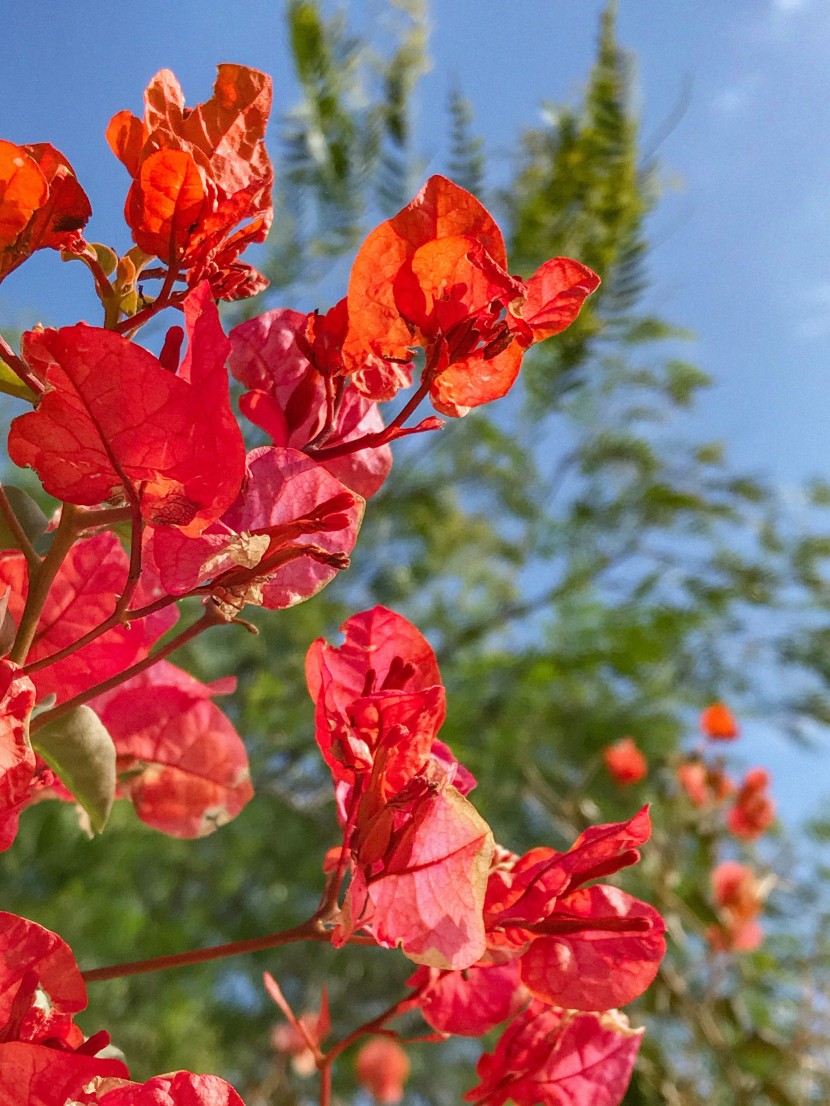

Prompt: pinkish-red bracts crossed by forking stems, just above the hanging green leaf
xmin=0 ymin=532 xmax=178 ymax=702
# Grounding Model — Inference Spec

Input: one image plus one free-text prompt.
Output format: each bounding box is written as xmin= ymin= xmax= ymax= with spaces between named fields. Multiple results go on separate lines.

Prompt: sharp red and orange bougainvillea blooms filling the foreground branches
xmin=0 ymin=64 xmax=664 ymax=1106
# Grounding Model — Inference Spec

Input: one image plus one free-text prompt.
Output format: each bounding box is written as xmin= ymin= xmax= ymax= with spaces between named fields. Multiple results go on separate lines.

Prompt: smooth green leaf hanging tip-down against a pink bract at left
xmin=32 ymin=707 xmax=115 ymax=833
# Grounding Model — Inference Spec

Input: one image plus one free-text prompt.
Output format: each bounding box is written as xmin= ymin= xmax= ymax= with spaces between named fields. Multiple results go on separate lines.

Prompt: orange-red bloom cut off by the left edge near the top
xmin=0 ymin=139 xmax=92 ymax=280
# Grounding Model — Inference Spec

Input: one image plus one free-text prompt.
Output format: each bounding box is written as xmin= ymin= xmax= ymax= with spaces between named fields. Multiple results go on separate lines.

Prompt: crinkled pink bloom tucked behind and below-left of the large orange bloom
xmin=230 ymin=309 xmax=393 ymax=498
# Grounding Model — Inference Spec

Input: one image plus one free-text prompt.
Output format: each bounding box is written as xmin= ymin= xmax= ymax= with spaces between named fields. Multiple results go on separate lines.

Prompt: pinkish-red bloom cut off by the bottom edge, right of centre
xmin=464 ymin=1001 xmax=643 ymax=1106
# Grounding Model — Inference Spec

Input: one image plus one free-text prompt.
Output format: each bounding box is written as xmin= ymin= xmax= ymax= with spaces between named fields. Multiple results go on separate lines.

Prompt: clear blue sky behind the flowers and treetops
xmin=0 ymin=0 xmax=830 ymax=812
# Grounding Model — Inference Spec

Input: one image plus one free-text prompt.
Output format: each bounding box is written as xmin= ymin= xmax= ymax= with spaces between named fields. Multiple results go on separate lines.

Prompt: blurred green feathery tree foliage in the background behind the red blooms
xmin=0 ymin=0 xmax=830 ymax=1106
